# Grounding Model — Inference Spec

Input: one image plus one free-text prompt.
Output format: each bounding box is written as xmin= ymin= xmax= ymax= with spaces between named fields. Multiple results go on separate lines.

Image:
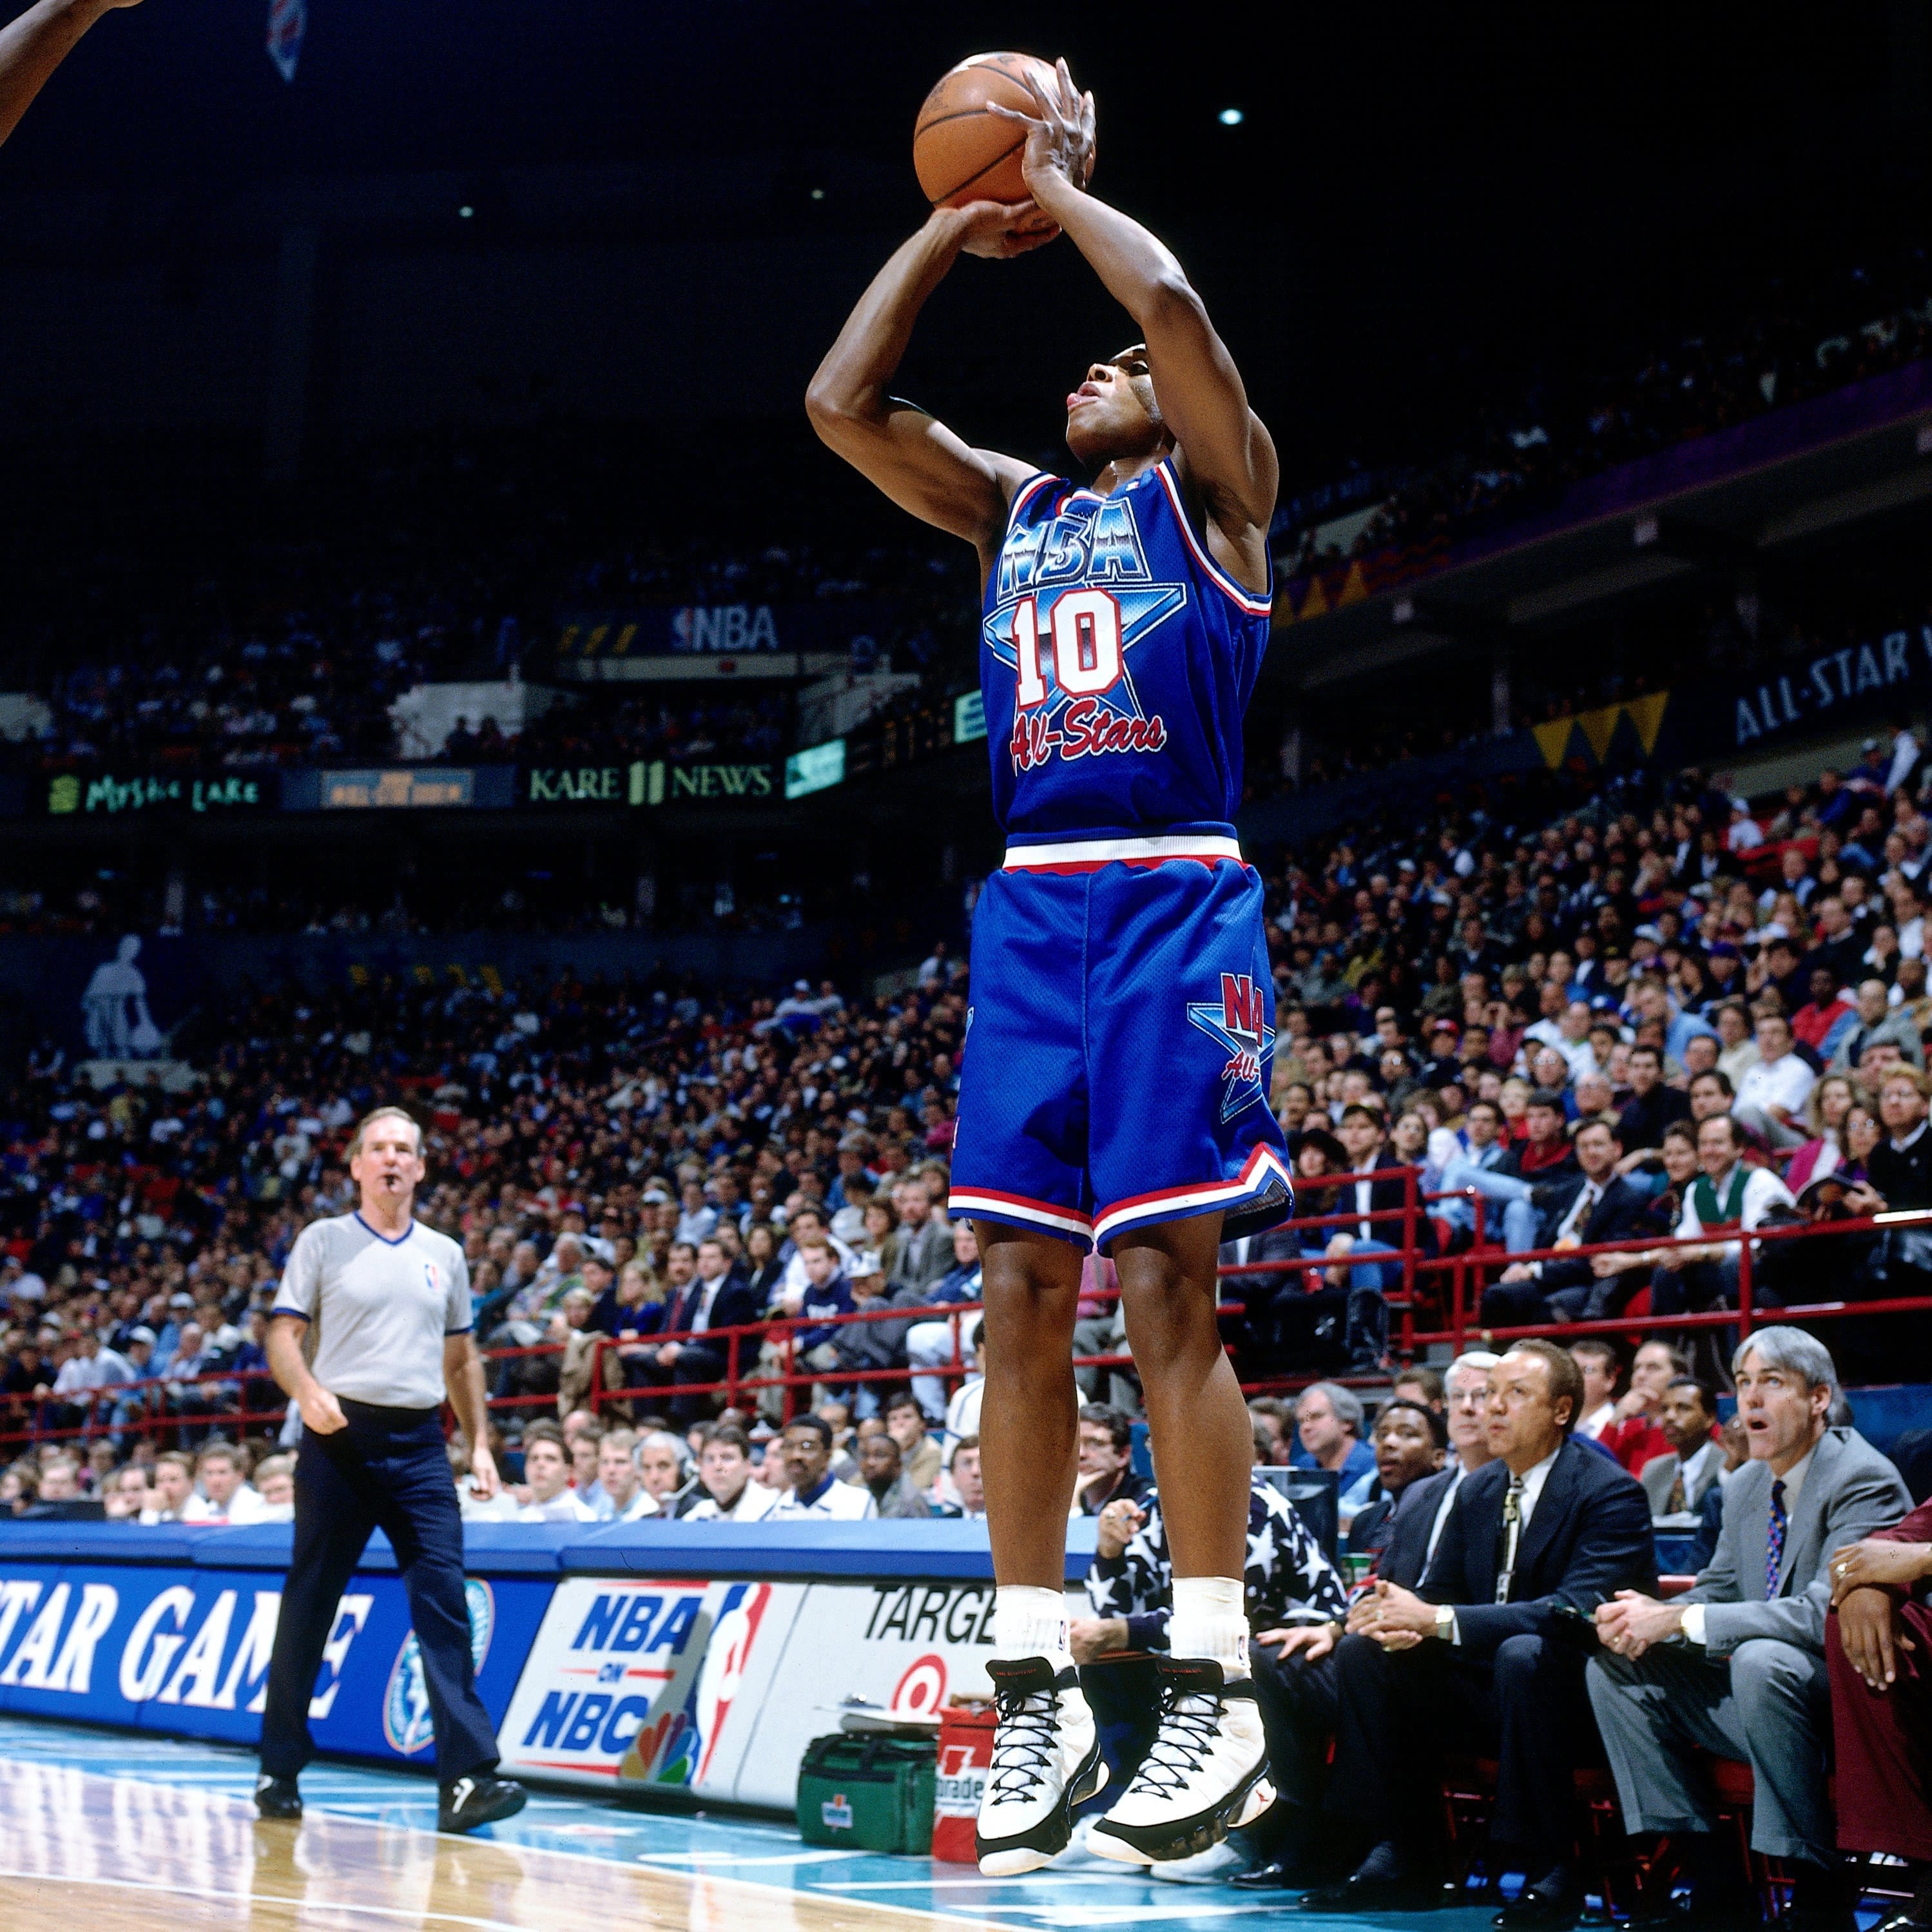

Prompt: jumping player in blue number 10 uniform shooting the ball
xmin=807 ymin=62 xmax=1293 ymax=1874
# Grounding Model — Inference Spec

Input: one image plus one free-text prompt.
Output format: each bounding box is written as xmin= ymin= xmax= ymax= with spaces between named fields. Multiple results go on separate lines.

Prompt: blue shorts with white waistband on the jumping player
xmin=949 ymin=825 xmax=1295 ymax=1250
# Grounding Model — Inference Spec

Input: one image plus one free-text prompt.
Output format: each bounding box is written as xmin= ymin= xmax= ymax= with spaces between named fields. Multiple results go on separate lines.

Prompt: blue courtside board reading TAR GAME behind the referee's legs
xmin=0 ymin=1563 xmax=552 ymax=1762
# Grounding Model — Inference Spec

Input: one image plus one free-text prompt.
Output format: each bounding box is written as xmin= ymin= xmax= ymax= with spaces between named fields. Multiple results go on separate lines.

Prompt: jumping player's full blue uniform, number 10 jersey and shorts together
xmin=951 ymin=462 xmax=1293 ymax=1248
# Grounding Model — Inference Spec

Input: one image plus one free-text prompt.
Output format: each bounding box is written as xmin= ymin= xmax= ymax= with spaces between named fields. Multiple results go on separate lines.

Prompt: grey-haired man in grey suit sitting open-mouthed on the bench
xmin=1586 ymin=1328 xmax=1911 ymax=1932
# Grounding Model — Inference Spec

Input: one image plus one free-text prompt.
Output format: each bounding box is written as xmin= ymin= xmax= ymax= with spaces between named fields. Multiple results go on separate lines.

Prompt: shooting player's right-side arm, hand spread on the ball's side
xmin=987 ymin=60 xmax=1281 ymax=545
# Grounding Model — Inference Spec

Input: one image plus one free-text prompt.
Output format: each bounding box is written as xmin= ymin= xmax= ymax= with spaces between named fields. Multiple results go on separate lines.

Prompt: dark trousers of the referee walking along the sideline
xmin=261 ymin=1401 xmax=496 ymax=1785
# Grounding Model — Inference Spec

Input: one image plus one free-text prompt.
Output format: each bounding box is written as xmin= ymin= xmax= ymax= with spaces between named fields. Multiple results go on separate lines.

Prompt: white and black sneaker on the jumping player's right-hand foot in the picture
xmin=1088 ymin=1657 xmax=1275 ymax=1864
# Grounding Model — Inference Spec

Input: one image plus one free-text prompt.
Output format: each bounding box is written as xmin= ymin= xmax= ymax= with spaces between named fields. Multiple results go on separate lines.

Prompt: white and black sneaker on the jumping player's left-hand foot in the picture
xmin=974 ymin=1657 xmax=1107 ymax=1878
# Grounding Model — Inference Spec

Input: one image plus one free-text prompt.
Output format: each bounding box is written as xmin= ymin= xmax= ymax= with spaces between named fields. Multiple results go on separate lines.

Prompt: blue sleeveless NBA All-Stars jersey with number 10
xmin=980 ymin=460 xmax=1270 ymax=835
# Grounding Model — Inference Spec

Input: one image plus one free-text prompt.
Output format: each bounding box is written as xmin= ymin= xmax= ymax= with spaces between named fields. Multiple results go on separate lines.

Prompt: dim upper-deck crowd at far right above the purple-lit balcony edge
xmin=1283 ymin=244 xmax=1932 ymax=570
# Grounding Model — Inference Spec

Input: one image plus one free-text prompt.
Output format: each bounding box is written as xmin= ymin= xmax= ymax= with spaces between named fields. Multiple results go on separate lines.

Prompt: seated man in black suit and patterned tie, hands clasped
xmin=1302 ymin=1341 xmax=1656 ymax=1932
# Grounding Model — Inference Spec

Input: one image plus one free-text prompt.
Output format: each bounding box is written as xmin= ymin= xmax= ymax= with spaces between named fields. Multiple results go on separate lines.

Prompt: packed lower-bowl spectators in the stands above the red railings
xmin=11 ymin=734 xmax=1932 ymax=1453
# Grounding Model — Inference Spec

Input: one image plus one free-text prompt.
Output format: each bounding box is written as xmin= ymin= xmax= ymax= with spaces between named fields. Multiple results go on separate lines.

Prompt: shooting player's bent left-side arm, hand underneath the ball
xmin=806 ymin=201 xmax=1051 ymax=566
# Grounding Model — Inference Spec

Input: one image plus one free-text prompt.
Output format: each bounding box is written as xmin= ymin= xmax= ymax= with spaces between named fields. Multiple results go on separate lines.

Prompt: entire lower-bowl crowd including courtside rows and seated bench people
xmin=0 ymin=734 xmax=1932 ymax=1932
